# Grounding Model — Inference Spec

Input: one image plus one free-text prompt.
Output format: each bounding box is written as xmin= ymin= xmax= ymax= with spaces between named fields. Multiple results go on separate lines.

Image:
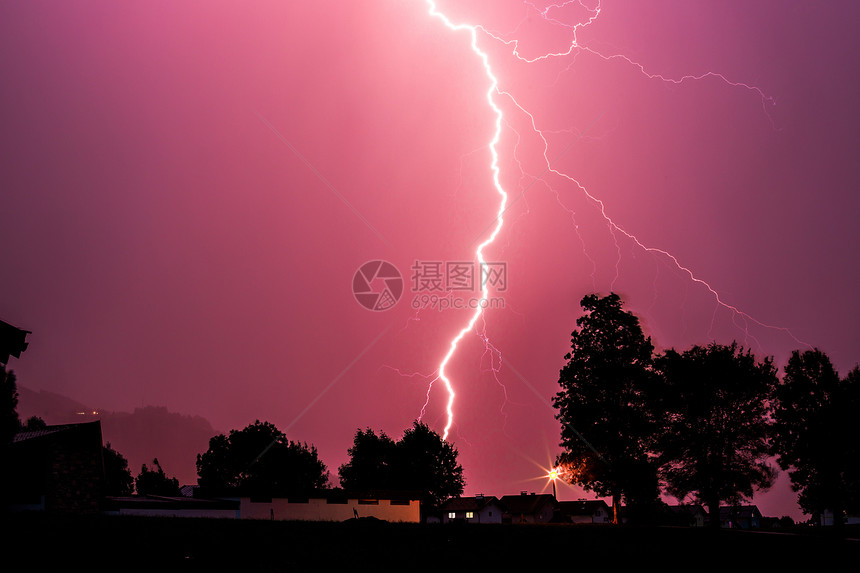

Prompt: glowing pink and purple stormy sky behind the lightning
xmin=0 ymin=0 xmax=860 ymax=517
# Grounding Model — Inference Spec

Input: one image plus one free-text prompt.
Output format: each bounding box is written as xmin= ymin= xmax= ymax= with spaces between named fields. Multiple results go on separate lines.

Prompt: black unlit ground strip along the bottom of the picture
xmin=3 ymin=514 xmax=860 ymax=572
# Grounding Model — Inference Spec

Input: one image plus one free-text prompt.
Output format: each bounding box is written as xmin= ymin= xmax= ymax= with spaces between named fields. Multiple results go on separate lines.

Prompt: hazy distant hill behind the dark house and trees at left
xmin=18 ymin=385 xmax=218 ymax=485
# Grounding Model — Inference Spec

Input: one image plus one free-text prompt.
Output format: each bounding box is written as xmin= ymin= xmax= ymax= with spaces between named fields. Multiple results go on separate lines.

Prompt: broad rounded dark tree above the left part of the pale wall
xmin=197 ymin=420 xmax=328 ymax=497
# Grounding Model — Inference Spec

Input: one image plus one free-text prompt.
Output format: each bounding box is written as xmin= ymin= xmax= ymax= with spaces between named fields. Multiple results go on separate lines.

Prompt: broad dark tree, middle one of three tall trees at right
xmin=657 ymin=343 xmax=777 ymax=527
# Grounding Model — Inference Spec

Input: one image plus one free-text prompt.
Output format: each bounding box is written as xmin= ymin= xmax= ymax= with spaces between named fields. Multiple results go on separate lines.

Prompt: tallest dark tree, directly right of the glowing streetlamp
xmin=553 ymin=293 xmax=659 ymax=523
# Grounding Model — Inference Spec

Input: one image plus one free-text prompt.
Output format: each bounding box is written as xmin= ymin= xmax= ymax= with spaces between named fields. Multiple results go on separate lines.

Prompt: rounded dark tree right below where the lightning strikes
xmin=338 ymin=422 xmax=465 ymax=507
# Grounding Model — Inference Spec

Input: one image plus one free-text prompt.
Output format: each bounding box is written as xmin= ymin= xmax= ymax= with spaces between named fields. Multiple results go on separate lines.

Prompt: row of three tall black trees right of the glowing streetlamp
xmin=553 ymin=294 xmax=860 ymax=527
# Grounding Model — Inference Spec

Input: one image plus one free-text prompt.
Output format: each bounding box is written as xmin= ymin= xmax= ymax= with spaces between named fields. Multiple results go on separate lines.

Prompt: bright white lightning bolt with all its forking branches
xmin=421 ymin=0 xmax=811 ymax=440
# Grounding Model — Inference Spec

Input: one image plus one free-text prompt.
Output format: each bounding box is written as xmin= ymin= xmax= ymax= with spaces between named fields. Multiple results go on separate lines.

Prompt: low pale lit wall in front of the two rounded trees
xmin=239 ymin=497 xmax=421 ymax=523
